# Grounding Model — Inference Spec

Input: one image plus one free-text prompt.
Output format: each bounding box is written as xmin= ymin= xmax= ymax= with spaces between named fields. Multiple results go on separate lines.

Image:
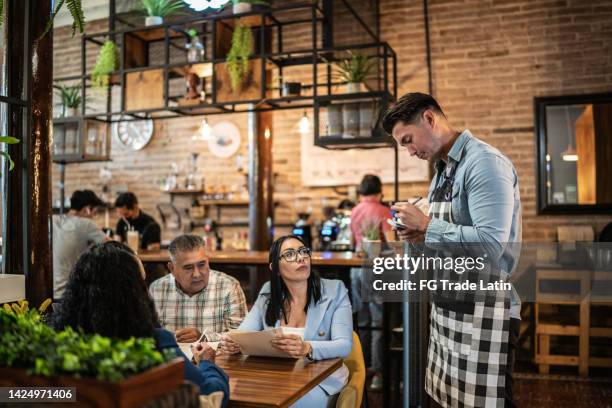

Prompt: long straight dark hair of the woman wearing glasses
xmin=266 ymin=235 xmax=321 ymax=326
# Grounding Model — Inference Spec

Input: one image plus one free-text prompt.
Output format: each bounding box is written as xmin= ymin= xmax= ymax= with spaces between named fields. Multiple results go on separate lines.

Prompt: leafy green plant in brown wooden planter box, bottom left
xmin=0 ymin=299 xmax=183 ymax=407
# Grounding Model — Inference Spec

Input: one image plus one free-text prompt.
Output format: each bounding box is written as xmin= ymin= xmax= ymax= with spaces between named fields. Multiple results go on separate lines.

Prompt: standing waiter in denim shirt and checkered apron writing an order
xmin=383 ymin=93 xmax=521 ymax=407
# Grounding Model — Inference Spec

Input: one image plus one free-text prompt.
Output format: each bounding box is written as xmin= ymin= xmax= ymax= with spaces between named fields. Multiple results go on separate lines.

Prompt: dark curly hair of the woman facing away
xmin=52 ymin=241 xmax=160 ymax=339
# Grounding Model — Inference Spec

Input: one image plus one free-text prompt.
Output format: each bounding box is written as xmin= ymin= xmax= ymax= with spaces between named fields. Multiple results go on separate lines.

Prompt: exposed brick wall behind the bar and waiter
xmin=53 ymin=0 xmax=612 ymax=241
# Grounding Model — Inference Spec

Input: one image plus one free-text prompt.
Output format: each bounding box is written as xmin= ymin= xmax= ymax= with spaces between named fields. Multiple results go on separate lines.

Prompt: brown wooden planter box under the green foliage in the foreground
xmin=0 ymin=358 xmax=184 ymax=408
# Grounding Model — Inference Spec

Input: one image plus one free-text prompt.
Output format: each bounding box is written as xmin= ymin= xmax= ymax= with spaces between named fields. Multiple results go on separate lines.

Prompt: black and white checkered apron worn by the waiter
xmin=425 ymin=162 xmax=510 ymax=407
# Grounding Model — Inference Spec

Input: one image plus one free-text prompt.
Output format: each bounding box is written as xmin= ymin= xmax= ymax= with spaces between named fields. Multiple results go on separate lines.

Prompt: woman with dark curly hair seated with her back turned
xmin=52 ymin=241 xmax=229 ymax=406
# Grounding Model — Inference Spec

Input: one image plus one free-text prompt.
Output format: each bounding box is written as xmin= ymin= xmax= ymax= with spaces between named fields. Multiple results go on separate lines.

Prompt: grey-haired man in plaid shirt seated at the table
xmin=149 ymin=235 xmax=247 ymax=343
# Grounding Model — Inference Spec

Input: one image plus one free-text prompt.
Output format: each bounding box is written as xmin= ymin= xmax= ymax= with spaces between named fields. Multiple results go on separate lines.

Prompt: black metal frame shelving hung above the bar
xmin=55 ymin=0 xmax=397 ymax=148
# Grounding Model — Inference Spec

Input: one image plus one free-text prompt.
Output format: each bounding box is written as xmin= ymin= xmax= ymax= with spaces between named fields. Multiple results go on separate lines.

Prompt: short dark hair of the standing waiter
xmin=382 ymin=92 xmax=445 ymax=134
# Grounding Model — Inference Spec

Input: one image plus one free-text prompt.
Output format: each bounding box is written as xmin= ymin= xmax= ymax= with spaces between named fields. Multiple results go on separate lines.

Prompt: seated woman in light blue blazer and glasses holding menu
xmin=221 ymin=235 xmax=353 ymax=407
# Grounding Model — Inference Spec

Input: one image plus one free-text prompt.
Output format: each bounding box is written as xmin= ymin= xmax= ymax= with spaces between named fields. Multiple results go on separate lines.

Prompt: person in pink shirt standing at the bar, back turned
xmin=351 ymin=174 xmax=395 ymax=391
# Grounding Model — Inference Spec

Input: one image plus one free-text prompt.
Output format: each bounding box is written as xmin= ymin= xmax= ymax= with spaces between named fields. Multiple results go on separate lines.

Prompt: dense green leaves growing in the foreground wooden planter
xmin=0 ymin=302 xmax=173 ymax=381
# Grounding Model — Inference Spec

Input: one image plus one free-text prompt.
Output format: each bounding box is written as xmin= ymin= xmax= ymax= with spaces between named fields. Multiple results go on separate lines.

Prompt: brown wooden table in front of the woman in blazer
xmin=215 ymin=354 xmax=342 ymax=407
